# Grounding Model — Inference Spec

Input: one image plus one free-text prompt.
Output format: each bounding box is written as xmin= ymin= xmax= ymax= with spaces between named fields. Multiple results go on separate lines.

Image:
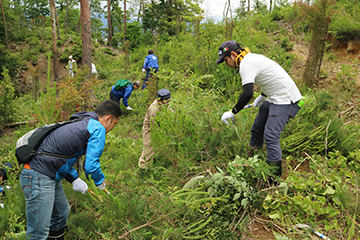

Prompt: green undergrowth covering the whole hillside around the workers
xmin=0 ymin=0 xmax=360 ymax=240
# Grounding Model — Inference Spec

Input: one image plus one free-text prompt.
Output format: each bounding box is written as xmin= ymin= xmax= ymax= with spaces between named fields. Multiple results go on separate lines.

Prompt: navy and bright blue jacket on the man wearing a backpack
xmin=29 ymin=112 xmax=106 ymax=186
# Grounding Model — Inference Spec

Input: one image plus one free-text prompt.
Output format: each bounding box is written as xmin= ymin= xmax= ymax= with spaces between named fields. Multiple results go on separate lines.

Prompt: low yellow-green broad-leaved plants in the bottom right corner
xmin=263 ymin=151 xmax=359 ymax=236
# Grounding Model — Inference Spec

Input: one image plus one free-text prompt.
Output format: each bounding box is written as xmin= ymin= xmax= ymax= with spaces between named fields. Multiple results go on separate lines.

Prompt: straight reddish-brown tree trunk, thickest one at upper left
xmin=80 ymin=0 xmax=92 ymax=79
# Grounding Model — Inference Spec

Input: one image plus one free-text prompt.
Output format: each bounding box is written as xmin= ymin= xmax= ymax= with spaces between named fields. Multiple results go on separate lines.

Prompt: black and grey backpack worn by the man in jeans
xmin=15 ymin=118 xmax=84 ymax=164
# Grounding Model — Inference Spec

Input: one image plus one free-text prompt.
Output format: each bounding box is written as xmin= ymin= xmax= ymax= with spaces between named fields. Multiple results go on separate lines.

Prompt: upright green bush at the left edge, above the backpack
xmin=0 ymin=68 xmax=16 ymax=124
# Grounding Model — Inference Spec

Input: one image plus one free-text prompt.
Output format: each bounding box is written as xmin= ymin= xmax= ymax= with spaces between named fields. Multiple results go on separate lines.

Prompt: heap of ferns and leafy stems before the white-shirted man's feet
xmin=172 ymin=156 xmax=269 ymax=239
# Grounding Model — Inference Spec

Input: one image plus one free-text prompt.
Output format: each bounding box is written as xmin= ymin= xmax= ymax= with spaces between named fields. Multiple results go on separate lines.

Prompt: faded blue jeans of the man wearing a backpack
xmin=20 ymin=168 xmax=70 ymax=240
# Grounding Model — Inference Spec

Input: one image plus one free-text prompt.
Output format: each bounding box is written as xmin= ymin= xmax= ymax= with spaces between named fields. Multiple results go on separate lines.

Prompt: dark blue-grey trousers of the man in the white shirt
xmin=250 ymin=101 xmax=300 ymax=162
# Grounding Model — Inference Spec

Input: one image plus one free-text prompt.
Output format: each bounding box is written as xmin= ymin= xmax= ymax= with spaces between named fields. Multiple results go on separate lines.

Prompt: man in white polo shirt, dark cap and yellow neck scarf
xmin=216 ymin=41 xmax=302 ymax=177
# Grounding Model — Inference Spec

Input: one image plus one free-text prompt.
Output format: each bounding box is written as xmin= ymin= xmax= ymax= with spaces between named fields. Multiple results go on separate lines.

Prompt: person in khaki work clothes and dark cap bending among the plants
xmin=138 ymin=89 xmax=171 ymax=169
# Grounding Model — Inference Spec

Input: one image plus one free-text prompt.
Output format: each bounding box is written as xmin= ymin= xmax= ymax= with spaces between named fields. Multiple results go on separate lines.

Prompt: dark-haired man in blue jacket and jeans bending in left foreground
xmin=20 ymin=100 xmax=121 ymax=240
